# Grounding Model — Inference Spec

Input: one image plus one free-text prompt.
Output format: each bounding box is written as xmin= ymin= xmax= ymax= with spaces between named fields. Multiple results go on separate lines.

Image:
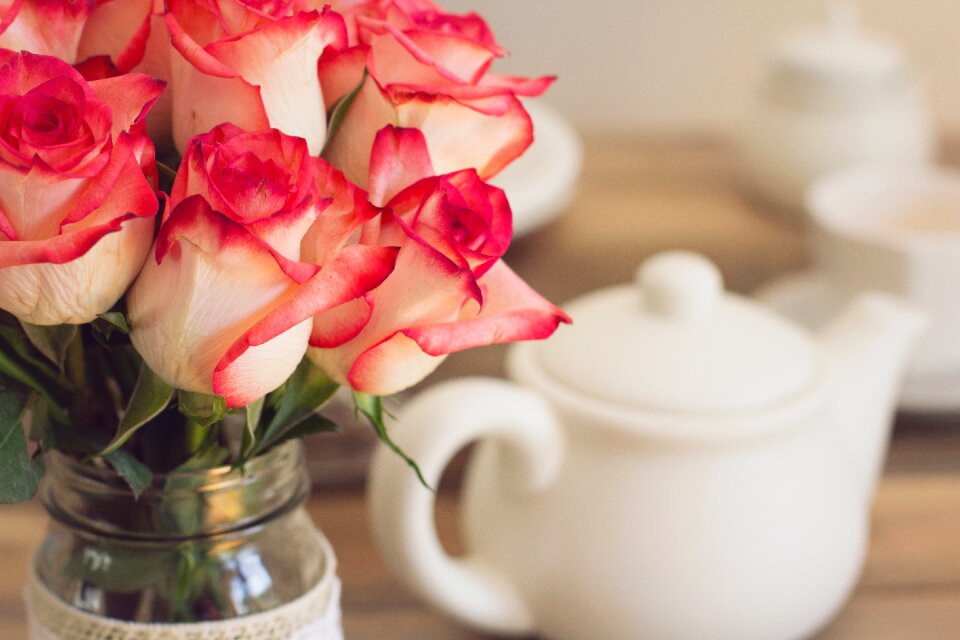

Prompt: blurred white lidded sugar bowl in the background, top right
xmin=740 ymin=3 xmax=934 ymax=213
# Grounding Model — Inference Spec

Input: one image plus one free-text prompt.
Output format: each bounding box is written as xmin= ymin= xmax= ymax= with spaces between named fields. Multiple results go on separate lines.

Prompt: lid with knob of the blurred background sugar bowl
xmin=772 ymin=2 xmax=912 ymax=98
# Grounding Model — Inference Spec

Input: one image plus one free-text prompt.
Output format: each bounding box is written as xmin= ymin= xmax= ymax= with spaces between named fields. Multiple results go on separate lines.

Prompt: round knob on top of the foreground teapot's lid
xmin=637 ymin=251 xmax=723 ymax=322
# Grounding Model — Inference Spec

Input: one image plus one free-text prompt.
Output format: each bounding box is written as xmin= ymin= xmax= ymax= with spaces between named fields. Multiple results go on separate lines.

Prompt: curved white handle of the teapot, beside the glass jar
xmin=367 ymin=378 xmax=564 ymax=635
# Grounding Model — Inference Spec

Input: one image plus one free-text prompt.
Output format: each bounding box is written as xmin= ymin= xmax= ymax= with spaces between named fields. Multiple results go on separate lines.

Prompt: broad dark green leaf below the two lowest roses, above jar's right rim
xmin=254 ymin=358 xmax=339 ymax=454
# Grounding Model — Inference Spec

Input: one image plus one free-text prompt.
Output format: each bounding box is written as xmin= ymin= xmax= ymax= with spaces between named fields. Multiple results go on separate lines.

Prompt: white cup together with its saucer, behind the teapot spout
xmin=757 ymin=165 xmax=960 ymax=412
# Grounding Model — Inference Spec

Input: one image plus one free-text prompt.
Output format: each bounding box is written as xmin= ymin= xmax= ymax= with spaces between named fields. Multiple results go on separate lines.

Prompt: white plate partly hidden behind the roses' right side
xmin=490 ymin=100 xmax=583 ymax=237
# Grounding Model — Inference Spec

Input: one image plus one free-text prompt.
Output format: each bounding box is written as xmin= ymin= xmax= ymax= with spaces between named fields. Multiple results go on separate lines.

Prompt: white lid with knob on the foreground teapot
xmin=533 ymin=251 xmax=817 ymax=413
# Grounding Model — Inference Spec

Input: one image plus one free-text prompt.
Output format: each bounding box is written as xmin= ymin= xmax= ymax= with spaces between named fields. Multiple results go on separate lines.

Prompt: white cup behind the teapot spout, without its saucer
xmin=809 ymin=165 xmax=960 ymax=376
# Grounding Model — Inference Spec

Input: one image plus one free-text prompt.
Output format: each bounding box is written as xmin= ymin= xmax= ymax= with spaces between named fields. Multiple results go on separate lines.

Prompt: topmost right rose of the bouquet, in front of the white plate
xmin=319 ymin=0 xmax=552 ymax=186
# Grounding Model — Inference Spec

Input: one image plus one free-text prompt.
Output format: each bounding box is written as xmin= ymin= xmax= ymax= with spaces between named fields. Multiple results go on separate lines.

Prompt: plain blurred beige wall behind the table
xmin=439 ymin=0 xmax=960 ymax=135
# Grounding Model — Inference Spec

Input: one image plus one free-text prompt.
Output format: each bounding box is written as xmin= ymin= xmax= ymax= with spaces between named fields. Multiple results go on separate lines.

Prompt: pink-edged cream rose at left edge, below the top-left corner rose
xmin=0 ymin=51 xmax=163 ymax=325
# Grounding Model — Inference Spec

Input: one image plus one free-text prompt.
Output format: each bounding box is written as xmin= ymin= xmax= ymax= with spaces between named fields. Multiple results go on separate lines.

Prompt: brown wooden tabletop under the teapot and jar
xmin=0 ymin=139 xmax=960 ymax=640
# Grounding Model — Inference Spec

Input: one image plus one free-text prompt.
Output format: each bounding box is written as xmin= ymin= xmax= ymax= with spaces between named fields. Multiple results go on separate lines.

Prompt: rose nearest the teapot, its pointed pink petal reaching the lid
xmin=308 ymin=127 xmax=569 ymax=395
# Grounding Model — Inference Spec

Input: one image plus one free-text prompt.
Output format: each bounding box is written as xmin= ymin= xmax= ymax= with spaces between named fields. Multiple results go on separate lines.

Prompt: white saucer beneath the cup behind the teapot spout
xmin=754 ymin=271 xmax=960 ymax=413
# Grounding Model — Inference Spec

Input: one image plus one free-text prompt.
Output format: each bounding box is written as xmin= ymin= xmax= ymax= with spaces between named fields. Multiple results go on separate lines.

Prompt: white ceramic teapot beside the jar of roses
xmin=368 ymin=252 xmax=924 ymax=640
